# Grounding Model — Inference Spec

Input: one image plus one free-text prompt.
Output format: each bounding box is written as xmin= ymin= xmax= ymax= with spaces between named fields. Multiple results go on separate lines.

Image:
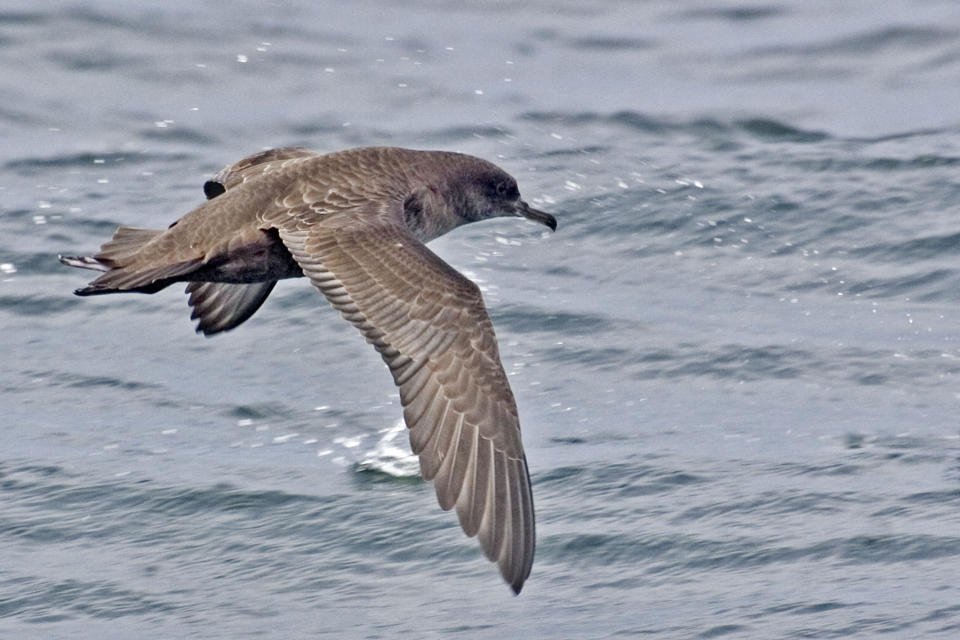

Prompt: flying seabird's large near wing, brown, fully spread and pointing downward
xmin=273 ymin=202 xmax=535 ymax=593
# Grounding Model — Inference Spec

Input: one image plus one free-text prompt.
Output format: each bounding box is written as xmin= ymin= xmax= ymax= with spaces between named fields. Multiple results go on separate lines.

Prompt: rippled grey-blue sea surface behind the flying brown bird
xmin=0 ymin=0 xmax=960 ymax=640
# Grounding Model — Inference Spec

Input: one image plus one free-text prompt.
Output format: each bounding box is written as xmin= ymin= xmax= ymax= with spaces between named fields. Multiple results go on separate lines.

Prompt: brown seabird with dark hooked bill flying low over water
xmin=59 ymin=147 xmax=557 ymax=594
